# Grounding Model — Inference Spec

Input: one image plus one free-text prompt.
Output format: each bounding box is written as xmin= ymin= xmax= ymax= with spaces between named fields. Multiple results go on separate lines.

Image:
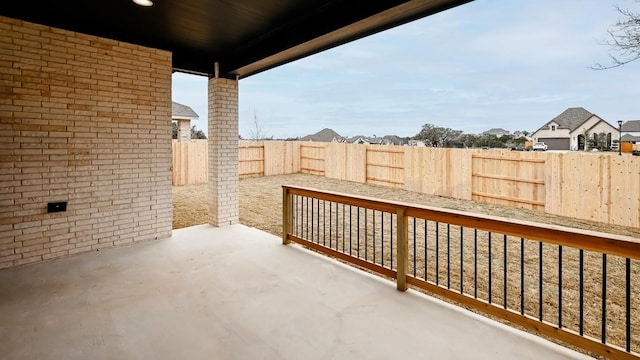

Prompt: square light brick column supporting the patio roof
xmin=208 ymin=78 xmax=239 ymax=226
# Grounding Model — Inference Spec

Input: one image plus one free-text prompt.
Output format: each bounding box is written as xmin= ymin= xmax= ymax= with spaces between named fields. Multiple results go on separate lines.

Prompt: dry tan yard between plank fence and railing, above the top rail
xmin=173 ymin=174 xmax=640 ymax=238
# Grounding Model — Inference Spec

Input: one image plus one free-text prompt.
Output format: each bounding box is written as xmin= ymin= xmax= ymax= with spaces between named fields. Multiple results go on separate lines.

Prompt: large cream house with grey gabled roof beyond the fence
xmin=531 ymin=107 xmax=619 ymax=150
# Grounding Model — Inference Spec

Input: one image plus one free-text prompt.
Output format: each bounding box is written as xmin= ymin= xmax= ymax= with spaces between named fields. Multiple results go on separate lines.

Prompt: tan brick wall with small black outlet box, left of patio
xmin=0 ymin=17 xmax=172 ymax=268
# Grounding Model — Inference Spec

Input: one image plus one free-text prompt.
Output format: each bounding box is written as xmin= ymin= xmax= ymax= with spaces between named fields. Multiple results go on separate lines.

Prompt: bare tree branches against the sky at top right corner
xmin=591 ymin=0 xmax=640 ymax=70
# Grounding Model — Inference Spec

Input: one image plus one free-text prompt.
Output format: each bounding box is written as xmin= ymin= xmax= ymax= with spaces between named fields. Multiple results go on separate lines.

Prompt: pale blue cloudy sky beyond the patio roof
xmin=173 ymin=0 xmax=640 ymax=138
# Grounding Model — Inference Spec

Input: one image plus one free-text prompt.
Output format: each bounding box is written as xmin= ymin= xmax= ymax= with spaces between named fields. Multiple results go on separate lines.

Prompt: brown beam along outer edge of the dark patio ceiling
xmin=228 ymin=0 xmax=473 ymax=78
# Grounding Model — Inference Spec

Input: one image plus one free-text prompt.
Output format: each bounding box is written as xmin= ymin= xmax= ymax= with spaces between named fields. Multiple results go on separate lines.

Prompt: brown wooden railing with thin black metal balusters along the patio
xmin=282 ymin=186 xmax=640 ymax=359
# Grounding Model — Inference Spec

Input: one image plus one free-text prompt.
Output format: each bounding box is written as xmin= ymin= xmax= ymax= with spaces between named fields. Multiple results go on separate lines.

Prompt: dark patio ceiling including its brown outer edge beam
xmin=0 ymin=0 xmax=471 ymax=78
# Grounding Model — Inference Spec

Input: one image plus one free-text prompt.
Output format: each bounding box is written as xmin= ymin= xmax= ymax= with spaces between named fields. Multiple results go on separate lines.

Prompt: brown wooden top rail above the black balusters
xmin=282 ymin=185 xmax=640 ymax=260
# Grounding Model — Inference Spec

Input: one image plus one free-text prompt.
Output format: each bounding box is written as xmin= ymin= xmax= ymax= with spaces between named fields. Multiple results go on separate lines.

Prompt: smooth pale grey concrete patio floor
xmin=0 ymin=225 xmax=586 ymax=360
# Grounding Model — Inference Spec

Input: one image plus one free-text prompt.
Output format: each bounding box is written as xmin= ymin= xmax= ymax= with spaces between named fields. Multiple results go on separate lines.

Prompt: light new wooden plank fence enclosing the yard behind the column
xmin=174 ymin=141 xmax=640 ymax=227
